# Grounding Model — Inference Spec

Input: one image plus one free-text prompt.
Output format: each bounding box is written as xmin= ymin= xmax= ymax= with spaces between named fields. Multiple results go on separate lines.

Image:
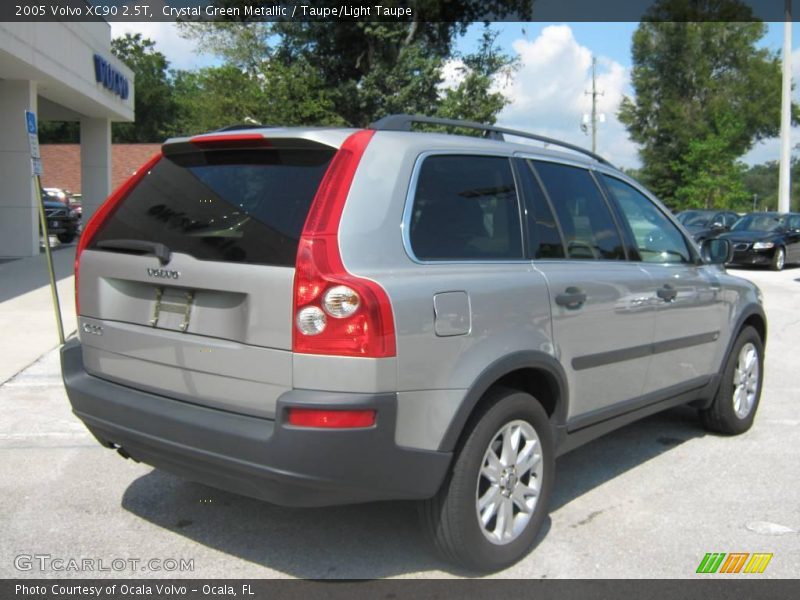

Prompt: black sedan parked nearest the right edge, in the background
xmin=718 ymin=212 xmax=800 ymax=271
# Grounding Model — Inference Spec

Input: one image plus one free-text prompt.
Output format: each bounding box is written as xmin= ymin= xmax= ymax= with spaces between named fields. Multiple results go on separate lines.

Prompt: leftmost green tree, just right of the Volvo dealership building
xmin=111 ymin=33 xmax=175 ymax=143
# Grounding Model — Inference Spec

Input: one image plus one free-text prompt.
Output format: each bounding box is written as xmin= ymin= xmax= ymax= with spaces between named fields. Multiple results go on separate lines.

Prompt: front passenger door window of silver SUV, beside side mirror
xmin=603 ymin=175 xmax=691 ymax=263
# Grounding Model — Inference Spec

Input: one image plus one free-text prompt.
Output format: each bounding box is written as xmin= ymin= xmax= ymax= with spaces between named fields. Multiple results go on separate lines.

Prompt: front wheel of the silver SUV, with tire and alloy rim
xmin=700 ymin=327 xmax=764 ymax=435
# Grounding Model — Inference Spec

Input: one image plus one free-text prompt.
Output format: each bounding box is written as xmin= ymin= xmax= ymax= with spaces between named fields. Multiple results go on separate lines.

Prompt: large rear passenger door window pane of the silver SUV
xmin=534 ymin=161 xmax=625 ymax=260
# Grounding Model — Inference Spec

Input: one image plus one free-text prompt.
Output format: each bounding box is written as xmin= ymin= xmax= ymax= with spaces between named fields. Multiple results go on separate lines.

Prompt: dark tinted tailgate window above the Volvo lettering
xmin=92 ymin=149 xmax=335 ymax=266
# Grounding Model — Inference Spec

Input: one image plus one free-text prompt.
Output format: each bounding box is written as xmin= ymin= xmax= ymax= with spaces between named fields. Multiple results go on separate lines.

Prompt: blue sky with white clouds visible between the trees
xmin=111 ymin=22 xmax=800 ymax=168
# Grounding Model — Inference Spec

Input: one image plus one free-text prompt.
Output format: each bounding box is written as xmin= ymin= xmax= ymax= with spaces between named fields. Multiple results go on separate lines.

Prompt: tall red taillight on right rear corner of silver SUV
xmin=292 ymin=130 xmax=395 ymax=358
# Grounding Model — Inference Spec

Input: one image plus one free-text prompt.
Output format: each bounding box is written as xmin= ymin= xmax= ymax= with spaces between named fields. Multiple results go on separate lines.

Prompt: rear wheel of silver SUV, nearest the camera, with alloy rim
xmin=420 ymin=388 xmax=555 ymax=572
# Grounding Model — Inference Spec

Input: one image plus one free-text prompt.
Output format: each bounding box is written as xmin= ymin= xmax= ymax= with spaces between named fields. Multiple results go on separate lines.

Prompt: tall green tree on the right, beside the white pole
xmin=619 ymin=0 xmax=792 ymax=206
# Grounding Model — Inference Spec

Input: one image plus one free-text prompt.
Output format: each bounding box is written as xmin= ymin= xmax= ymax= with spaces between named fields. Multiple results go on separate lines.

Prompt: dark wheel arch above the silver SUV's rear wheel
xmin=439 ymin=351 xmax=569 ymax=452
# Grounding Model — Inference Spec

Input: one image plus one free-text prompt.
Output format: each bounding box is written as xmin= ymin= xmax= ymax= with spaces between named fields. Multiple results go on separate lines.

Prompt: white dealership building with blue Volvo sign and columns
xmin=0 ymin=21 xmax=134 ymax=258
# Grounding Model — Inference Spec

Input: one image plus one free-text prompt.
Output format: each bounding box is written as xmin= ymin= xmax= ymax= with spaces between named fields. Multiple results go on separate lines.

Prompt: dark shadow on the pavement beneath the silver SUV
xmin=122 ymin=408 xmax=703 ymax=579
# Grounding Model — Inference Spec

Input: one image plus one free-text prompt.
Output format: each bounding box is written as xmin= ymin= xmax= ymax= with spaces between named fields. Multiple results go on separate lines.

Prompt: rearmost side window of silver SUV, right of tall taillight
xmin=409 ymin=155 xmax=523 ymax=260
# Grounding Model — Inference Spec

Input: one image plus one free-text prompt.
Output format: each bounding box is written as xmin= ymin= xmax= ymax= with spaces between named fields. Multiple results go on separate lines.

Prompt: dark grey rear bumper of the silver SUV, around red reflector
xmin=61 ymin=340 xmax=451 ymax=506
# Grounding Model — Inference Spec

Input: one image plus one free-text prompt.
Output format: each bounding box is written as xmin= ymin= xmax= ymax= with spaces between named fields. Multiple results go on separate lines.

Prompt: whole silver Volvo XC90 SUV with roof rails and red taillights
xmin=62 ymin=115 xmax=766 ymax=571
